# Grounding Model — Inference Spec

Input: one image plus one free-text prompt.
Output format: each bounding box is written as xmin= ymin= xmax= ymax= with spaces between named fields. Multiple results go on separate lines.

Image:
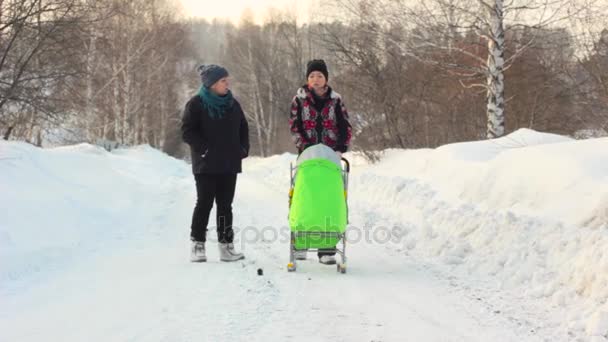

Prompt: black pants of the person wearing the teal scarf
xmin=190 ymin=173 xmax=236 ymax=243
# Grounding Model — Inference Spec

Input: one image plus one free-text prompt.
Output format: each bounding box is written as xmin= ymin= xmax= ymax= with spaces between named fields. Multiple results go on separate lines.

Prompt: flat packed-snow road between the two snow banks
xmin=0 ymin=146 xmax=529 ymax=341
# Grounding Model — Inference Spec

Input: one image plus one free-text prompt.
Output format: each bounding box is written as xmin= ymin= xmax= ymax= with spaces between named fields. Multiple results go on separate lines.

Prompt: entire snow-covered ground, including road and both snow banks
xmin=0 ymin=130 xmax=608 ymax=342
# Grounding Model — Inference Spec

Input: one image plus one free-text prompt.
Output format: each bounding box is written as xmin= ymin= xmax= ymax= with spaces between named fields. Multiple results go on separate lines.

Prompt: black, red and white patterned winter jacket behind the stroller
xmin=289 ymin=85 xmax=352 ymax=152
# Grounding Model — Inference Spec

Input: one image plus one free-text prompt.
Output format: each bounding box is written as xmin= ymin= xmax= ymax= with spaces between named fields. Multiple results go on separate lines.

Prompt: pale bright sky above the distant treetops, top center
xmin=180 ymin=0 xmax=315 ymax=24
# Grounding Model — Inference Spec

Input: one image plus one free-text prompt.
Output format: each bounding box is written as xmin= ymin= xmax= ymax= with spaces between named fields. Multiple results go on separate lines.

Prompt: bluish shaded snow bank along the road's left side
xmin=0 ymin=141 xmax=189 ymax=292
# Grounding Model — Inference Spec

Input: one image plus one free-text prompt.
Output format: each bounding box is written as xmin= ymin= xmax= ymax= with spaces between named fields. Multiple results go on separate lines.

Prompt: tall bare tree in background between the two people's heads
xmin=228 ymin=13 xmax=303 ymax=156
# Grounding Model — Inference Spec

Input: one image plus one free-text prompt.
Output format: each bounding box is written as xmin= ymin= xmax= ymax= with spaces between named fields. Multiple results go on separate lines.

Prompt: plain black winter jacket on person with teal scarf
xmin=182 ymin=95 xmax=249 ymax=174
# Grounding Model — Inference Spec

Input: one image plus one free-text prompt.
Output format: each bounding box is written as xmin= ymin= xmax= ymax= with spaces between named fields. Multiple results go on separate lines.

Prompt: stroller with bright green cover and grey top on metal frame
xmin=287 ymin=144 xmax=350 ymax=273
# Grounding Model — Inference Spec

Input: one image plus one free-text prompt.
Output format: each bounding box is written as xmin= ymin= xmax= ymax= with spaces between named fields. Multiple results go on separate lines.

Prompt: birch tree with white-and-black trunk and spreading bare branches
xmin=328 ymin=0 xmax=581 ymax=138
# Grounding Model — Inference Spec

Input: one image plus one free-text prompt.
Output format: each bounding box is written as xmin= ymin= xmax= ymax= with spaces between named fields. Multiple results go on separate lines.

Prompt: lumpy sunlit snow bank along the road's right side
xmin=351 ymin=130 xmax=608 ymax=336
